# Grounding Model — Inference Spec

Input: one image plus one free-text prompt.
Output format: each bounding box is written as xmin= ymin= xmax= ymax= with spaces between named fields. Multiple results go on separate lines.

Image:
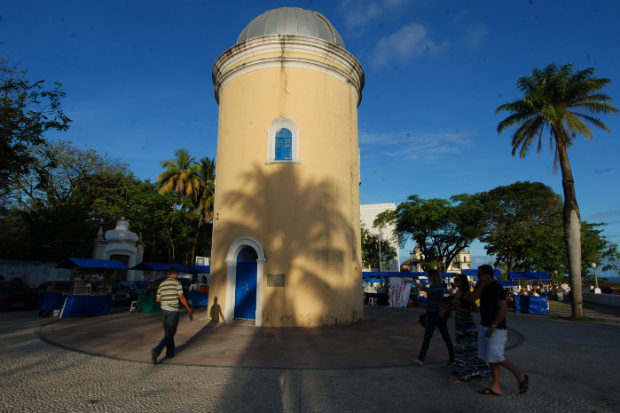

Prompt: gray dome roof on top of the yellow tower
xmin=237 ymin=7 xmax=345 ymax=49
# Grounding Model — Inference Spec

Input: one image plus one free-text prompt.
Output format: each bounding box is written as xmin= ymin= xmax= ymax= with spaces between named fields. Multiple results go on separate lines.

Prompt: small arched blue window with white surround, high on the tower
xmin=267 ymin=118 xmax=299 ymax=164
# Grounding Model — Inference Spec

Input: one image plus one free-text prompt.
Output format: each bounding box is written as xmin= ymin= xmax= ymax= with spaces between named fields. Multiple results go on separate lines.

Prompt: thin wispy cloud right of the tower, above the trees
xmin=359 ymin=131 xmax=473 ymax=162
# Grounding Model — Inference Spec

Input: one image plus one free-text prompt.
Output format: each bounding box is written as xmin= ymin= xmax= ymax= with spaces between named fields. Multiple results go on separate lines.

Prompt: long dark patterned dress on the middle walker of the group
xmin=450 ymin=300 xmax=491 ymax=381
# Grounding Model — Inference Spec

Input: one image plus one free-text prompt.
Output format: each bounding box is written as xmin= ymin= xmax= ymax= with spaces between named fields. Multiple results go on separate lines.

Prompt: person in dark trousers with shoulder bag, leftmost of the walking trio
xmin=410 ymin=270 xmax=454 ymax=367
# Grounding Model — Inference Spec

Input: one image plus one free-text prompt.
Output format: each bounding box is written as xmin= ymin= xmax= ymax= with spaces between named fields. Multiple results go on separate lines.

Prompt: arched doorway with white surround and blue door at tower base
xmin=223 ymin=237 xmax=267 ymax=327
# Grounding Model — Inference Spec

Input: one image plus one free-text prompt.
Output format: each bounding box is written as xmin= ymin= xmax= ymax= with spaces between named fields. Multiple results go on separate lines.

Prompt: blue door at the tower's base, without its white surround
xmin=235 ymin=247 xmax=257 ymax=320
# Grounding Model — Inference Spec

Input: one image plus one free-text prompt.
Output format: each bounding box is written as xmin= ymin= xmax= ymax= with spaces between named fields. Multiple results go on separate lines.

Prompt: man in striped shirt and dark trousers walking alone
xmin=151 ymin=268 xmax=193 ymax=364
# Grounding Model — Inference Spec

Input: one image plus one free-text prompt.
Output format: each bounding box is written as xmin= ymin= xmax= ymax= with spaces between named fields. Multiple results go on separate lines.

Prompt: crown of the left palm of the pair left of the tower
xmin=157 ymin=149 xmax=200 ymax=200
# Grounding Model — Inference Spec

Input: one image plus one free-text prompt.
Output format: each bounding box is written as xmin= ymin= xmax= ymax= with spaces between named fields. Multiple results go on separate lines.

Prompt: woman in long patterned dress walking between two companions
xmin=448 ymin=274 xmax=491 ymax=384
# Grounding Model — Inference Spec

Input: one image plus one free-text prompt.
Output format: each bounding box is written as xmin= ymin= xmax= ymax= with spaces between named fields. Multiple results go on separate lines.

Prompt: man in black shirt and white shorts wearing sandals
xmin=474 ymin=265 xmax=529 ymax=396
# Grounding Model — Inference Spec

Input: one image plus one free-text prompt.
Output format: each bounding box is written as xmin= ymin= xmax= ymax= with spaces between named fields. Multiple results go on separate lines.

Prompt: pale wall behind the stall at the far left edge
xmin=0 ymin=260 xmax=71 ymax=288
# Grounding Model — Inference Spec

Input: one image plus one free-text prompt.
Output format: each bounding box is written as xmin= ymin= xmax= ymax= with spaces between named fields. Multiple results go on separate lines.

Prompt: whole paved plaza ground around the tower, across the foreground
xmin=0 ymin=300 xmax=620 ymax=413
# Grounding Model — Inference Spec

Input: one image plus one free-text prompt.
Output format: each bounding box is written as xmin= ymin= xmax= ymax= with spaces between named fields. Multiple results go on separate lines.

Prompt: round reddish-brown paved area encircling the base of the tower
xmin=40 ymin=307 xmax=519 ymax=369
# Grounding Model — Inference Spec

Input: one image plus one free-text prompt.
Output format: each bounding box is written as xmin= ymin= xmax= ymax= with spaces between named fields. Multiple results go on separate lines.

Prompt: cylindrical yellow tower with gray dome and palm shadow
xmin=209 ymin=8 xmax=364 ymax=327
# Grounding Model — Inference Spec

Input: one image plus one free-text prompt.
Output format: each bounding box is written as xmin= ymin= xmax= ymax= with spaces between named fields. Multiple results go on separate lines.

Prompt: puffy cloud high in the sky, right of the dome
xmin=372 ymin=23 xmax=445 ymax=69
